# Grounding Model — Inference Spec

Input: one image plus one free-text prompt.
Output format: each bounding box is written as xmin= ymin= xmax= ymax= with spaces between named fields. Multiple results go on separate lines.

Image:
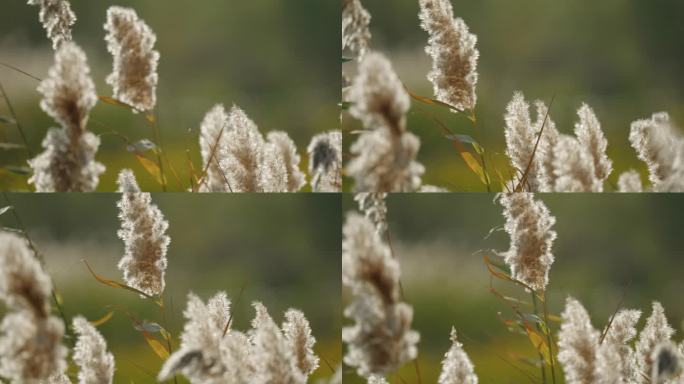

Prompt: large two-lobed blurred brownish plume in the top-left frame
xmin=29 ymin=42 xmax=105 ymax=192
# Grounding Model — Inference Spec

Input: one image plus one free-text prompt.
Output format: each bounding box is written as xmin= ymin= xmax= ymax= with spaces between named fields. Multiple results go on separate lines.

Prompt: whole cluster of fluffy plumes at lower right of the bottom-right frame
xmin=558 ymin=298 xmax=684 ymax=384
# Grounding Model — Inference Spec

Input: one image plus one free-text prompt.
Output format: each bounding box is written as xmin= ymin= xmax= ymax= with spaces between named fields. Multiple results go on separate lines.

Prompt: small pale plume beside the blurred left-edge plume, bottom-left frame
xmin=73 ymin=316 xmax=114 ymax=384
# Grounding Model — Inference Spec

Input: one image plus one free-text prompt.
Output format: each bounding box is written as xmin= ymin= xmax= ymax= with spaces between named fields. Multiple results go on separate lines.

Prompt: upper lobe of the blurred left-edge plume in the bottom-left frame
xmin=0 ymin=232 xmax=52 ymax=318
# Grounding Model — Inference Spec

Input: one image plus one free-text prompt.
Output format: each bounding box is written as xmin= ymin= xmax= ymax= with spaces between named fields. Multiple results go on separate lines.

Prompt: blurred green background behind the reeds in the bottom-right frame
xmin=343 ymin=194 xmax=684 ymax=384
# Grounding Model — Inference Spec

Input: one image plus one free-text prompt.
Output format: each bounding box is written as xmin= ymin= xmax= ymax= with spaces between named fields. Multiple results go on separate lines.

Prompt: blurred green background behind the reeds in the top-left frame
xmin=0 ymin=0 xmax=341 ymax=191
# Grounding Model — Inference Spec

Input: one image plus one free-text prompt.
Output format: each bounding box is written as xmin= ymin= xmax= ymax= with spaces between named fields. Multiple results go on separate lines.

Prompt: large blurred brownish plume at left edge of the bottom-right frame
xmin=342 ymin=213 xmax=420 ymax=377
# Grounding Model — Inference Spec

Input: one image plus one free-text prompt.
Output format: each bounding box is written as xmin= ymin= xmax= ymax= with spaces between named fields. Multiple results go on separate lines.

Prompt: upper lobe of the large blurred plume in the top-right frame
xmin=349 ymin=52 xmax=411 ymax=135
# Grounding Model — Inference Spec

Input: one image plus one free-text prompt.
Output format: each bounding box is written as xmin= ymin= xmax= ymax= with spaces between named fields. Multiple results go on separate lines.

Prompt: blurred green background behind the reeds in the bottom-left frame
xmin=0 ymin=193 xmax=342 ymax=383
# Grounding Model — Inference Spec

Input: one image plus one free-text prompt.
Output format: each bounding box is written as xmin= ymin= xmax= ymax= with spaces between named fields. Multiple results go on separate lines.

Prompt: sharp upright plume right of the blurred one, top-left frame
xmin=104 ymin=6 xmax=159 ymax=112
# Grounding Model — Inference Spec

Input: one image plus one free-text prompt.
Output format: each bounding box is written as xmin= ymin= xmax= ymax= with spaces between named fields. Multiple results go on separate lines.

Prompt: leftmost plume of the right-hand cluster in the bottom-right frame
xmin=558 ymin=297 xmax=600 ymax=384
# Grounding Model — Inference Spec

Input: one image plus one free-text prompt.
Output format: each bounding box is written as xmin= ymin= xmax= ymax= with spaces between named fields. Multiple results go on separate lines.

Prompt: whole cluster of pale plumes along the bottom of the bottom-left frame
xmin=159 ymin=292 xmax=319 ymax=384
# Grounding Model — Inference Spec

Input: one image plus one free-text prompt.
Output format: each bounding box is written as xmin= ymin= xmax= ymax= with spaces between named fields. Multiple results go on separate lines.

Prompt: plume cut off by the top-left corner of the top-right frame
xmin=342 ymin=0 xmax=371 ymax=60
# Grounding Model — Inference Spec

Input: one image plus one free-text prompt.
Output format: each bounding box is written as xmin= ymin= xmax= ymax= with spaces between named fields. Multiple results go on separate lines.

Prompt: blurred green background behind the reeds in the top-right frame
xmin=343 ymin=0 xmax=684 ymax=191
